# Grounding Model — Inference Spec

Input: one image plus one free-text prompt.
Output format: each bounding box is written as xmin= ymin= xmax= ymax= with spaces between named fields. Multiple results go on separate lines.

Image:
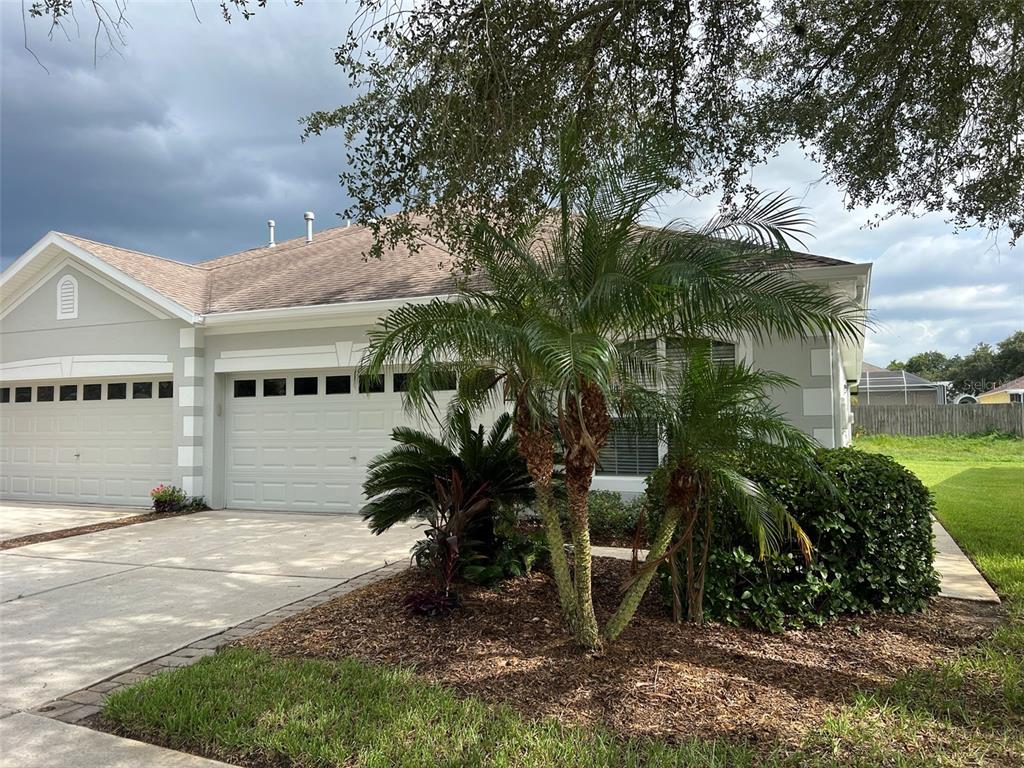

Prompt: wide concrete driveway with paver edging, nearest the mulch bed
xmin=0 ymin=511 xmax=417 ymax=715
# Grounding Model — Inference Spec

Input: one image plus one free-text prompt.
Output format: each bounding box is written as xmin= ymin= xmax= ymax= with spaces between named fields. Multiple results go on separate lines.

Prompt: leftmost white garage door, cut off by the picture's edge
xmin=0 ymin=380 xmax=174 ymax=506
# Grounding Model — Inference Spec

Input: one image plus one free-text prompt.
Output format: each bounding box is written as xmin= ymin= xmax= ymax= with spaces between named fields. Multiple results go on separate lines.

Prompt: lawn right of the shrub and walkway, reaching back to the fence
xmin=817 ymin=435 xmax=1024 ymax=766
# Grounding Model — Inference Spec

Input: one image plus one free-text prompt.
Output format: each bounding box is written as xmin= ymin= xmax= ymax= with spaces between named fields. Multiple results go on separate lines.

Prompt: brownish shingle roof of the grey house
xmin=54 ymin=226 xmax=850 ymax=314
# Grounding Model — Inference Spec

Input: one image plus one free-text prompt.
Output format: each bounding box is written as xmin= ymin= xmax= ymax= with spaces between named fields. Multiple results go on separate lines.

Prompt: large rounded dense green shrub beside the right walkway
xmin=647 ymin=449 xmax=938 ymax=632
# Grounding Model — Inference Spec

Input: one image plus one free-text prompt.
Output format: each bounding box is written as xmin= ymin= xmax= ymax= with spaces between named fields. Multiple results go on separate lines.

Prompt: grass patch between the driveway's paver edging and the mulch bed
xmin=104 ymin=648 xmax=772 ymax=768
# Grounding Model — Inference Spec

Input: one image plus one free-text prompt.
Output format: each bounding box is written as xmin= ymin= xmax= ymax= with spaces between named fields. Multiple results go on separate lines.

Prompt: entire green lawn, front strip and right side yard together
xmin=104 ymin=437 xmax=1024 ymax=768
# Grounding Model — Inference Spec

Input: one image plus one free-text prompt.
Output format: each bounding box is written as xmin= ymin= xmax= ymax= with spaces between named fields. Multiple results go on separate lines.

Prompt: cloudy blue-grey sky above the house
xmin=0 ymin=0 xmax=1024 ymax=365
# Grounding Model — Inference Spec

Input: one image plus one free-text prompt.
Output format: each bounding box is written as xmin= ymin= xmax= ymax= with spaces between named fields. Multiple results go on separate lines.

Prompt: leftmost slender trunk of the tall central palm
xmin=516 ymin=409 xmax=579 ymax=634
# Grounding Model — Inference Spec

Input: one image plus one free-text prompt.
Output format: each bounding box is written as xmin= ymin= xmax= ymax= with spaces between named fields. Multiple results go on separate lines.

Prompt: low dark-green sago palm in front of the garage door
xmin=359 ymin=409 xmax=534 ymax=536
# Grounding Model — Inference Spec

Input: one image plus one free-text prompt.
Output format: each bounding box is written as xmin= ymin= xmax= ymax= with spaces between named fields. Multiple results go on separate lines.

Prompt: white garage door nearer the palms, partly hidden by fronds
xmin=225 ymin=372 xmax=452 ymax=512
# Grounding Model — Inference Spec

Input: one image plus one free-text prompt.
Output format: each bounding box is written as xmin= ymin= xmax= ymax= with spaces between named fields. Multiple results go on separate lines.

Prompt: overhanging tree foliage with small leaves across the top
xmin=28 ymin=0 xmax=1024 ymax=249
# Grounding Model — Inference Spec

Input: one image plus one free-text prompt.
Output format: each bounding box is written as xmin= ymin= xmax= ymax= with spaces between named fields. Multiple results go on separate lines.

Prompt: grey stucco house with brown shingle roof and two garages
xmin=0 ymin=224 xmax=870 ymax=512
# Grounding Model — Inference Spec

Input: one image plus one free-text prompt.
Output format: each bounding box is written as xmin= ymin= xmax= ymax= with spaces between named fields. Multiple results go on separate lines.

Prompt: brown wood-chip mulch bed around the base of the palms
xmin=241 ymin=558 xmax=1001 ymax=744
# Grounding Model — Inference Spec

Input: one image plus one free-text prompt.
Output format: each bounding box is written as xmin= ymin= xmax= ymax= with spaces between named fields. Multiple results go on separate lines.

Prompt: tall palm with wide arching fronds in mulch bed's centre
xmin=362 ymin=144 xmax=861 ymax=648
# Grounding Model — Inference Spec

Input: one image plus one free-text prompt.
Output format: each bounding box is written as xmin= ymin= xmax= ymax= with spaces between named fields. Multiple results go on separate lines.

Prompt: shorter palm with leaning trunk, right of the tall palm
xmin=604 ymin=348 xmax=820 ymax=642
